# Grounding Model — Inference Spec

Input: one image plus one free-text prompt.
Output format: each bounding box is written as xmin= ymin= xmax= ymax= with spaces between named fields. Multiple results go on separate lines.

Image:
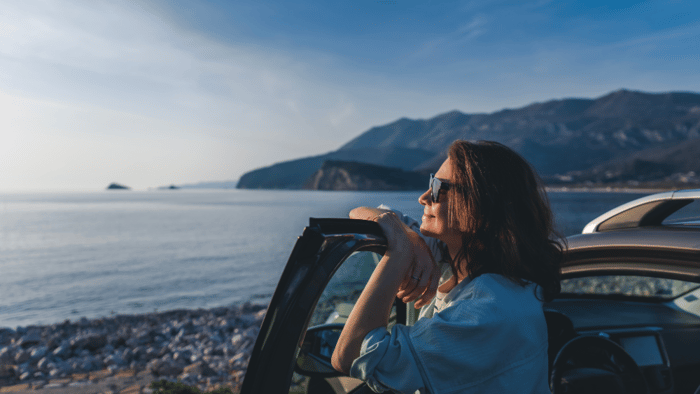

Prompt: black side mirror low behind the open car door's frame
xmin=294 ymin=323 xmax=344 ymax=378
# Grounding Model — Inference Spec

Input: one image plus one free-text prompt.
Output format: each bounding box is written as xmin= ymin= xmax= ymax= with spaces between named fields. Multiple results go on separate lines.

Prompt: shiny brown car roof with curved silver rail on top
xmin=562 ymin=189 xmax=700 ymax=281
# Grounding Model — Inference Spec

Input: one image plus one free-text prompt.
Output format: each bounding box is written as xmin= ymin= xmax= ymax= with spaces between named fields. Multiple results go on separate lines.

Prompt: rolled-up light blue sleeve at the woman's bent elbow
xmin=350 ymin=325 xmax=425 ymax=393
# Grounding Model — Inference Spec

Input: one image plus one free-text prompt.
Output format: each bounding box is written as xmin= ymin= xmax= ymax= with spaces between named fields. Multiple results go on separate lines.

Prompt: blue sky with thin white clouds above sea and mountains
xmin=0 ymin=0 xmax=700 ymax=192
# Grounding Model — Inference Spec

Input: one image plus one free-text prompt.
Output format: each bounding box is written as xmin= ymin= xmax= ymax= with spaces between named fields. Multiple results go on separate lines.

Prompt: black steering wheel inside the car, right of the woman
xmin=549 ymin=335 xmax=649 ymax=394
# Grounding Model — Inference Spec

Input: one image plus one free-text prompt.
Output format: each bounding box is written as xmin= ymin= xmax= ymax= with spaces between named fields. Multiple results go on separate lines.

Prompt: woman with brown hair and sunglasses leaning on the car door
xmin=332 ymin=141 xmax=562 ymax=393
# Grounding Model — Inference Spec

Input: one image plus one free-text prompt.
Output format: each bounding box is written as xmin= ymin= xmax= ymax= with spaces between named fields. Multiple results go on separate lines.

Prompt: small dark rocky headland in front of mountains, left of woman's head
xmin=304 ymin=160 xmax=428 ymax=190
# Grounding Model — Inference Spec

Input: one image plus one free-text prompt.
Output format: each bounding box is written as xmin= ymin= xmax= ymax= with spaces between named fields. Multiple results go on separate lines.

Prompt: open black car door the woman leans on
xmin=241 ymin=218 xmax=396 ymax=394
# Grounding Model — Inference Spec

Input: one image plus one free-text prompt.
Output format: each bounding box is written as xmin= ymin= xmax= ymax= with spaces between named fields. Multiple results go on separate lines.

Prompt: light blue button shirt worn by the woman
xmin=350 ymin=208 xmax=549 ymax=394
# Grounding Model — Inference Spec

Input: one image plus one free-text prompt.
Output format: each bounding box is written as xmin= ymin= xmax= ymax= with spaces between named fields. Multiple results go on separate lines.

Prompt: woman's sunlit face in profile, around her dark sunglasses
xmin=418 ymin=158 xmax=462 ymax=251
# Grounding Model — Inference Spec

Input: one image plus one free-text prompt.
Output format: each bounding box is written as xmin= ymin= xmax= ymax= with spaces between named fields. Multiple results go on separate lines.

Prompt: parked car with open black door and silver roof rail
xmin=241 ymin=190 xmax=700 ymax=394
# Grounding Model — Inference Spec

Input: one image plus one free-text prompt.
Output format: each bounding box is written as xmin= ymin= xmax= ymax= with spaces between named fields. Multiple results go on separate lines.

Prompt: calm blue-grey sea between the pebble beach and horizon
xmin=0 ymin=190 xmax=644 ymax=327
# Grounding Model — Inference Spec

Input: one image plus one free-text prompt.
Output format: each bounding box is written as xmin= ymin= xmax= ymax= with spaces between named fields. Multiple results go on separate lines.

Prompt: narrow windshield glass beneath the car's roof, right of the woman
xmin=561 ymin=275 xmax=700 ymax=299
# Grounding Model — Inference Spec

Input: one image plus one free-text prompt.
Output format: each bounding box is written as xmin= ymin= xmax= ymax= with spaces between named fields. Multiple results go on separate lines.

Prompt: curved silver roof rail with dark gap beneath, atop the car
xmin=581 ymin=189 xmax=700 ymax=234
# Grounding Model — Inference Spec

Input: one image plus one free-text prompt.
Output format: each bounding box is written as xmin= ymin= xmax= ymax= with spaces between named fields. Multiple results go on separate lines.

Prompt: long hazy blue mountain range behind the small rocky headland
xmin=238 ymin=90 xmax=700 ymax=189
